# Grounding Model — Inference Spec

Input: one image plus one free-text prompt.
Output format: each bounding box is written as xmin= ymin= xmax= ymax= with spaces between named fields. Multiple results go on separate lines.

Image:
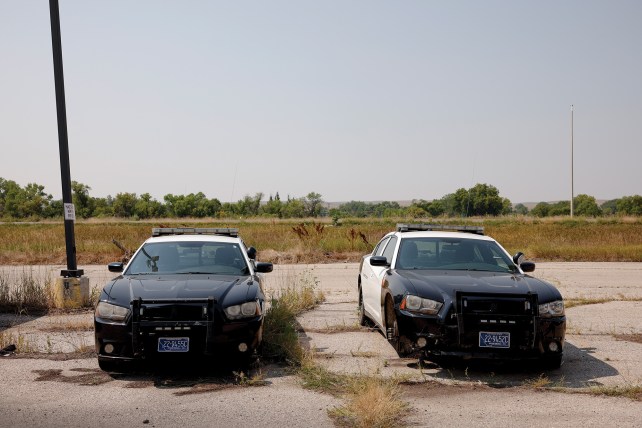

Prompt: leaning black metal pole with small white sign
xmin=49 ymin=0 xmax=83 ymax=277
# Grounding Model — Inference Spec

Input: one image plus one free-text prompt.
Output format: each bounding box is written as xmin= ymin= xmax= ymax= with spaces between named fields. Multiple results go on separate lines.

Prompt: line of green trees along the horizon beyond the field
xmin=0 ymin=177 xmax=642 ymax=220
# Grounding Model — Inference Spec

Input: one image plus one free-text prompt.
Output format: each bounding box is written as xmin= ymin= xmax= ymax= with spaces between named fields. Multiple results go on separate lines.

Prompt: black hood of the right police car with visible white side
xmin=397 ymin=270 xmax=561 ymax=302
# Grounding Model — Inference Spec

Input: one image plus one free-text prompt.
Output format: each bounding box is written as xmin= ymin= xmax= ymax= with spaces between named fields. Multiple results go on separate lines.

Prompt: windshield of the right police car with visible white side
xmin=395 ymin=238 xmax=518 ymax=273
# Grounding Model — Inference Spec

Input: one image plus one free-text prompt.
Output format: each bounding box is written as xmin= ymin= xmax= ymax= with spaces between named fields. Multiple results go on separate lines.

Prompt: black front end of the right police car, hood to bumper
xmin=395 ymin=272 xmax=566 ymax=366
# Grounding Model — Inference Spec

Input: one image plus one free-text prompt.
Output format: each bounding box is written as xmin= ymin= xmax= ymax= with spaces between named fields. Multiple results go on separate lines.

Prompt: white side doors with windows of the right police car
xmin=361 ymin=236 xmax=397 ymax=328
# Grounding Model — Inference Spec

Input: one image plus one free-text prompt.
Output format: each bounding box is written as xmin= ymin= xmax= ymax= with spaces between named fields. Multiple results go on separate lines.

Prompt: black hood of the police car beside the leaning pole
xmin=104 ymin=275 xmax=256 ymax=306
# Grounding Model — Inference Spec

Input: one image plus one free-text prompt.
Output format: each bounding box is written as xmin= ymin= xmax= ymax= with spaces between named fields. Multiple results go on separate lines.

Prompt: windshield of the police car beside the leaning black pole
xmin=125 ymin=241 xmax=249 ymax=275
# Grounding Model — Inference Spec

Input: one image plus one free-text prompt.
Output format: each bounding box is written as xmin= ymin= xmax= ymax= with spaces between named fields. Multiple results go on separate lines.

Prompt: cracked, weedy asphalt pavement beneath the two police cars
xmin=0 ymin=263 xmax=642 ymax=427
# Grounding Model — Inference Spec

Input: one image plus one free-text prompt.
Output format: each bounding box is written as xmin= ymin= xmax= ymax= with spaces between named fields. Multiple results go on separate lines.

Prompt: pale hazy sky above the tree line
xmin=0 ymin=0 xmax=642 ymax=203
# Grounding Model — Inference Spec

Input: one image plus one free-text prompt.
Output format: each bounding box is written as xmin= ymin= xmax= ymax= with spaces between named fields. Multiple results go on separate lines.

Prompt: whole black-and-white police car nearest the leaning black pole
xmin=94 ymin=229 xmax=272 ymax=370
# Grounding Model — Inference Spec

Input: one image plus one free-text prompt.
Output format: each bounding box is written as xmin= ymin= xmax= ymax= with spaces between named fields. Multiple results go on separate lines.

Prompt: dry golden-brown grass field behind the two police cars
xmin=0 ymin=217 xmax=642 ymax=265
